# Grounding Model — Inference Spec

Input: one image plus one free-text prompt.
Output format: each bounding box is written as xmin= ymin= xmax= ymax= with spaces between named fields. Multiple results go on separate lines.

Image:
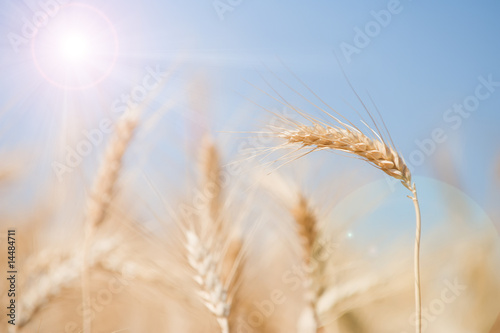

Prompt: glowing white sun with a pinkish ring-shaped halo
xmin=31 ymin=3 xmax=118 ymax=90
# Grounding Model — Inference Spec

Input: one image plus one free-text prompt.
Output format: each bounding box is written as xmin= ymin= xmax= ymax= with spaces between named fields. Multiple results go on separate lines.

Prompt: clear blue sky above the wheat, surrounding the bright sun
xmin=0 ymin=0 xmax=500 ymax=219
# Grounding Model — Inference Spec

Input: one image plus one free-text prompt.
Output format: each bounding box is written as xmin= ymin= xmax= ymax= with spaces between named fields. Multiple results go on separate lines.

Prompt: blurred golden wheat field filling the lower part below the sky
xmin=2 ymin=67 xmax=500 ymax=333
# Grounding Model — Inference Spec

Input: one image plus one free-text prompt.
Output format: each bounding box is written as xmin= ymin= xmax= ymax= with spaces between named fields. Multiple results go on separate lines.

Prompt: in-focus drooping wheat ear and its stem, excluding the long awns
xmin=277 ymin=121 xmax=422 ymax=333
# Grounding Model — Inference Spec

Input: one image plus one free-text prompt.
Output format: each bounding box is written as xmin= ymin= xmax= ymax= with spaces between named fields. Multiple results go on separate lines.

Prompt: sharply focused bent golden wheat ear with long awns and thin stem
xmin=258 ymin=67 xmax=421 ymax=333
